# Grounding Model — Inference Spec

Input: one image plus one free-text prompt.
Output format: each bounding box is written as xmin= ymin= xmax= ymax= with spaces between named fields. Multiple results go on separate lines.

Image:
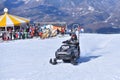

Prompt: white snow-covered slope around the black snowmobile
xmin=0 ymin=34 xmax=120 ymax=80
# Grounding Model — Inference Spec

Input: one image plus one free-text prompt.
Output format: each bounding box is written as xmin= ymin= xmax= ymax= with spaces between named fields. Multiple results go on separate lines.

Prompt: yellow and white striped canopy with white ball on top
xmin=0 ymin=8 xmax=30 ymax=27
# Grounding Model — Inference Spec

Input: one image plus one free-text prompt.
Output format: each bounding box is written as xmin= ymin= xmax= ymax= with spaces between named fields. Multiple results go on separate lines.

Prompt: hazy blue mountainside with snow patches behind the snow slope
xmin=0 ymin=0 xmax=120 ymax=32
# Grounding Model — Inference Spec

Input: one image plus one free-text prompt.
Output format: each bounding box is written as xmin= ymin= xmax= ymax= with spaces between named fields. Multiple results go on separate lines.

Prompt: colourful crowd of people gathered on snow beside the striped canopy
xmin=1 ymin=25 xmax=65 ymax=41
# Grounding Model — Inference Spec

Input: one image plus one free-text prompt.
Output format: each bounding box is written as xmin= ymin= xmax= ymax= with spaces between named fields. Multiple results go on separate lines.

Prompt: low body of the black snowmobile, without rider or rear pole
xmin=49 ymin=42 xmax=80 ymax=65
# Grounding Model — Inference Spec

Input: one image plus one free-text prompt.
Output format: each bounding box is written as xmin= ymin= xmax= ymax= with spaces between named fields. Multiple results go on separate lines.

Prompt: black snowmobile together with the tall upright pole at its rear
xmin=49 ymin=24 xmax=80 ymax=65
